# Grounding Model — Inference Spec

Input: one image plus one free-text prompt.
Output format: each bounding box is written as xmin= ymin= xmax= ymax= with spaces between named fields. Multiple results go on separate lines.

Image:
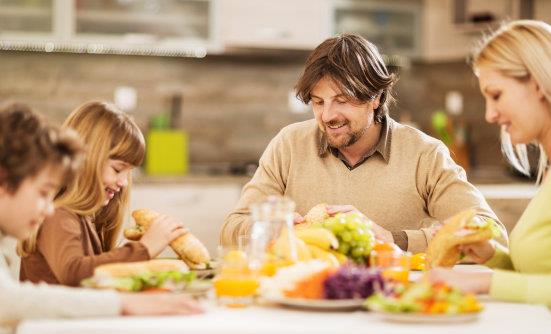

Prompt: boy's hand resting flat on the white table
xmin=121 ymin=293 xmax=203 ymax=315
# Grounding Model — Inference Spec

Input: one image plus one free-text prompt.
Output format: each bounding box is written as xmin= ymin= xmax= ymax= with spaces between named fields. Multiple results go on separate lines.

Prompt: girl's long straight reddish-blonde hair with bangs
xmin=19 ymin=101 xmax=145 ymax=255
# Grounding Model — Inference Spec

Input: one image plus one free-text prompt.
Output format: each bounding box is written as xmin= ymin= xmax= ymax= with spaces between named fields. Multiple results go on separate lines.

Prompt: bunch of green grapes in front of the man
xmin=319 ymin=213 xmax=375 ymax=264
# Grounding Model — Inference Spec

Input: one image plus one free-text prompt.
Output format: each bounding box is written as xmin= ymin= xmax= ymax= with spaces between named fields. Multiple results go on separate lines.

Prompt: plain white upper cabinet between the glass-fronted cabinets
xmin=220 ymin=0 xmax=332 ymax=49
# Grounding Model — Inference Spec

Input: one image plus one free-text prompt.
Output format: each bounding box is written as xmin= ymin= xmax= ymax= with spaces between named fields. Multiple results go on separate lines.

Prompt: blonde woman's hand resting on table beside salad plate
xmin=425 ymin=268 xmax=492 ymax=294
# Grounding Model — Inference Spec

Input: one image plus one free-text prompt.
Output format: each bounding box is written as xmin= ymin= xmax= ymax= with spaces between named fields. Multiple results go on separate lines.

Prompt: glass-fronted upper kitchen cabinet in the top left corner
xmin=0 ymin=0 xmax=218 ymax=57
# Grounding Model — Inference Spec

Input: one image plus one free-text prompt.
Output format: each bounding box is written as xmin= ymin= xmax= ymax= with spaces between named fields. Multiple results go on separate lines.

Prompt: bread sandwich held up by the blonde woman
xmin=427 ymin=209 xmax=492 ymax=268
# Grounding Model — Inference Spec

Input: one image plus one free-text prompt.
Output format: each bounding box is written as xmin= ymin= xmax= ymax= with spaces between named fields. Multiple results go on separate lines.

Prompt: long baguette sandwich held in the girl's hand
xmin=124 ymin=209 xmax=210 ymax=267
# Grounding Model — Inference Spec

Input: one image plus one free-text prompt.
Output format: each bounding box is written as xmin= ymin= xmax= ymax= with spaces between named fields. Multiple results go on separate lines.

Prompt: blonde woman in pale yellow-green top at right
xmin=429 ymin=20 xmax=551 ymax=305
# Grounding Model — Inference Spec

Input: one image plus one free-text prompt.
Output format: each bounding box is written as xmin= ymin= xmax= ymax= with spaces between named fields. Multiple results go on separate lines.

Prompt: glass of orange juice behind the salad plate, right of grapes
xmin=369 ymin=250 xmax=410 ymax=284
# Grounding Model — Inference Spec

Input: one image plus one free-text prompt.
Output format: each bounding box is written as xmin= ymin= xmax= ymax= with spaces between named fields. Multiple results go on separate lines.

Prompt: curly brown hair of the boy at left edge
xmin=0 ymin=102 xmax=84 ymax=192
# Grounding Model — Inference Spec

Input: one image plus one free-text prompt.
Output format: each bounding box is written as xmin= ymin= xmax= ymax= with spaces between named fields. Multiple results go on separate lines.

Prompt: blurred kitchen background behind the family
xmin=0 ymin=0 xmax=551 ymax=251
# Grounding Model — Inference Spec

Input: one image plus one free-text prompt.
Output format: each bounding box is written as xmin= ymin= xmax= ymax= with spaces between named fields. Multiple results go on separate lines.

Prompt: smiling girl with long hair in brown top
xmin=20 ymin=102 xmax=189 ymax=286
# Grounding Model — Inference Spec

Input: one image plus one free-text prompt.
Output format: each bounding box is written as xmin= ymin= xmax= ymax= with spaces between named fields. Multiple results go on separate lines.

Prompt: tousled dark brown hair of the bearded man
xmin=295 ymin=34 xmax=396 ymax=123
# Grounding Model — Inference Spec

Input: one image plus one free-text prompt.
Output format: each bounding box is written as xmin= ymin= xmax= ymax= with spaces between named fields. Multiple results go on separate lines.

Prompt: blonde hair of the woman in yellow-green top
xmin=472 ymin=20 xmax=551 ymax=183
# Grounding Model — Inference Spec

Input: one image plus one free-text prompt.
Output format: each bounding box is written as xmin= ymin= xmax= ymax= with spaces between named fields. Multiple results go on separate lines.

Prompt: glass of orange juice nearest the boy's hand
xmin=213 ymin=248 xmax=260 ymax=307
